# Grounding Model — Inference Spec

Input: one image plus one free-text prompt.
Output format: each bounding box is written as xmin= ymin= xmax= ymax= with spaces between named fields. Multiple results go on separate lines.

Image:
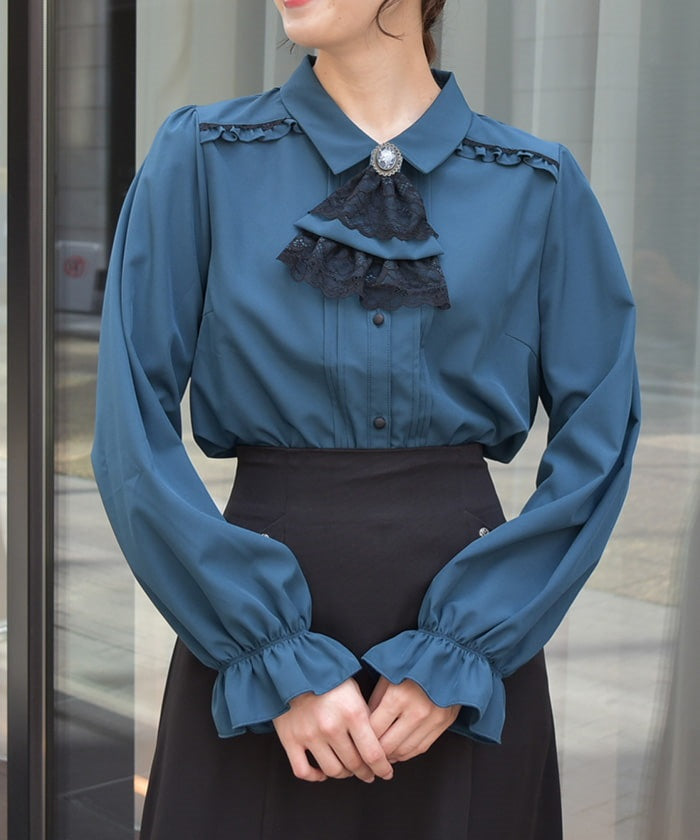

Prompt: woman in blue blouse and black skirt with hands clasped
xmin=93 ymin=0 xmax=639 ymax=840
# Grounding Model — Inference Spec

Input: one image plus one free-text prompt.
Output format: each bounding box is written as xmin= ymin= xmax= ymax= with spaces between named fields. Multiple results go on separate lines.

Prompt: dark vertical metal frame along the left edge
xmin=7 ymin=0 xmax=53 ymax=840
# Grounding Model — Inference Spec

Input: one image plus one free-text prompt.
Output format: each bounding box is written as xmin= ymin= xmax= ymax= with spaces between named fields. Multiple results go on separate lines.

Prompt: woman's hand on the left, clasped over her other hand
xmin=272 ymin=677 xmax=394 ymax=782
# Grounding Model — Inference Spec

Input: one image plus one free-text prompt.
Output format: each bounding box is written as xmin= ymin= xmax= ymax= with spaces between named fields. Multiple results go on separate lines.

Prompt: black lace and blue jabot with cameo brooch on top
xmin=277 ymin=143 xmax=450 ymax=310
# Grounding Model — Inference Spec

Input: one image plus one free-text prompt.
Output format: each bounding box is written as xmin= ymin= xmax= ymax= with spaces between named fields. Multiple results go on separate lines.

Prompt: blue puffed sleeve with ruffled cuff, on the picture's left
xmin=92 ymin=108 xmax=360 ymax=736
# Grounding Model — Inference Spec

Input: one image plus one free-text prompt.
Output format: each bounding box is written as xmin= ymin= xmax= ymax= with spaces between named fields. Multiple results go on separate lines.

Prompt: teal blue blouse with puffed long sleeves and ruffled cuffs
xmin=93 ymin=56 xmax=639 ymax=742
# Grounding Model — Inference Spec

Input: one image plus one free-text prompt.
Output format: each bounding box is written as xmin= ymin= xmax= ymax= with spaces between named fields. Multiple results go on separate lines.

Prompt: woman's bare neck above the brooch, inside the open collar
xmin=314 ymin=37 xmax=440 ymax=143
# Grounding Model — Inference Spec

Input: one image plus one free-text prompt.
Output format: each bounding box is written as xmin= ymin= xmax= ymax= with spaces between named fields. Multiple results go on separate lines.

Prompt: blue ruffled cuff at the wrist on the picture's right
xmin=361 ymin=630 xmax=505 ymax=744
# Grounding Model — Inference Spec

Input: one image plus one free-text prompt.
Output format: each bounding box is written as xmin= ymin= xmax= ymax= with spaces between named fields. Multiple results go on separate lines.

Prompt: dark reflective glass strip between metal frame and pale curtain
xmin=54 ymin=0 xmax=134 ymax=840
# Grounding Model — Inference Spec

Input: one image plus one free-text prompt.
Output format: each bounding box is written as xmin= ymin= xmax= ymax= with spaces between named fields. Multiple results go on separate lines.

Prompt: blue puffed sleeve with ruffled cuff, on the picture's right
xmin=362 ymin=147 xmax=640 ymax=742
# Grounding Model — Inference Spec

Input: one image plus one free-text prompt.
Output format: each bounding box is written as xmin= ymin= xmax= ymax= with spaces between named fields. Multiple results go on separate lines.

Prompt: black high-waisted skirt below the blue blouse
xmin=141 ymin=444 xmax=561 ymax=840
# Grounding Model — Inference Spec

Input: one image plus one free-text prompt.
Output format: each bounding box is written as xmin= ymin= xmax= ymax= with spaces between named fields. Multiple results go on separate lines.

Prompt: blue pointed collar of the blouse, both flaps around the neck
xmin=280 ymin=55 xmax=473 ymax=175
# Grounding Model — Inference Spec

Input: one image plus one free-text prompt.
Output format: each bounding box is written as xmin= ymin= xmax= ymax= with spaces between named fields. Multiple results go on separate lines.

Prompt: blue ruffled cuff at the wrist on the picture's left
xmin=212 ymin=630 xmax=361 ymax=738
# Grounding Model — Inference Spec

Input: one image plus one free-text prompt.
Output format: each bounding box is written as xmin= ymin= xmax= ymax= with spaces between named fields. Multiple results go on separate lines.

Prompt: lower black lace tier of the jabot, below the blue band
xmin=279 ymin=231 xmax=450 ymax=311
